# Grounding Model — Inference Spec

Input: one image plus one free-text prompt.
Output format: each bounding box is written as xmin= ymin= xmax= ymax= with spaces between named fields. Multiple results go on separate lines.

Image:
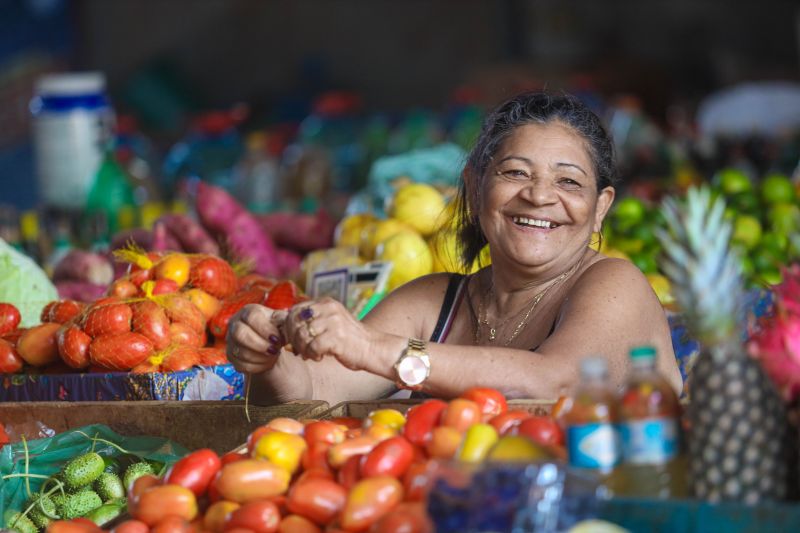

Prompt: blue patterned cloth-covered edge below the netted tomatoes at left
xmin=0 ymin=364 xmax=244 ymax=402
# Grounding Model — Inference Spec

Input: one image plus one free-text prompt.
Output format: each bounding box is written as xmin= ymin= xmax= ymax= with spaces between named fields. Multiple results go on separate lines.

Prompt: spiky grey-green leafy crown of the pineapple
xmin=656 ymin=186 xmax=744 ymax=348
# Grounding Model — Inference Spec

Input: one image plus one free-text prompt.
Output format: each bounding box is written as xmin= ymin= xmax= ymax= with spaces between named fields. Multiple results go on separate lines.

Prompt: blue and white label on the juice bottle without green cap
xmin=567 ymin=423 xmax=620 ymax=469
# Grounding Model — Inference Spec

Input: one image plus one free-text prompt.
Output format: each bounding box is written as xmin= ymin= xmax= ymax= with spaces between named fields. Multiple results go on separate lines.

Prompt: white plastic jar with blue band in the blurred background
xmin=30 ymin=72 xmax=114 ymax=209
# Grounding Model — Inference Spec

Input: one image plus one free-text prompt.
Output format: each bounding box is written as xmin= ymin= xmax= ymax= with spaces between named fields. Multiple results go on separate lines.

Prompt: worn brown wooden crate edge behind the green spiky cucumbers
xmin=0 ymin=401 xmax=329 ymax=453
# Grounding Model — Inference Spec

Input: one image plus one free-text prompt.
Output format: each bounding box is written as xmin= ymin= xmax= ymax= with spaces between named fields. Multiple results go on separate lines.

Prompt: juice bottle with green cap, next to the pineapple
xmin=613 ymin=346 xmax=686 ymax=498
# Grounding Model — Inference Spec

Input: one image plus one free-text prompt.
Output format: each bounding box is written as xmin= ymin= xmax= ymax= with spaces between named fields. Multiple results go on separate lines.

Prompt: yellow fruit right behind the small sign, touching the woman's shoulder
xmin=376 ymin=232 xmax=433 ymax=291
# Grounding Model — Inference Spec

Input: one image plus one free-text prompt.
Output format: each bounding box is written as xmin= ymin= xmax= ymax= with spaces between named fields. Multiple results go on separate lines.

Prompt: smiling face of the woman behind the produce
xmin=479 ymin=122 xmax=614 ymax=270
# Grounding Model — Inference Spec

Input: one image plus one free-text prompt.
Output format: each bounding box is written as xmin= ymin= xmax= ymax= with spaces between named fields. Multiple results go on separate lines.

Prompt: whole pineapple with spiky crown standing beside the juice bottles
xmin=658 ymin=188 xmax=787 ymax=503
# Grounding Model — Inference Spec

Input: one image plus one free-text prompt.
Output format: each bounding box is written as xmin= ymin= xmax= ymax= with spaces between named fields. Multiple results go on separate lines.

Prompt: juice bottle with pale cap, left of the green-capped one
xmin=564 ymin=357 xmax=620 ymax=476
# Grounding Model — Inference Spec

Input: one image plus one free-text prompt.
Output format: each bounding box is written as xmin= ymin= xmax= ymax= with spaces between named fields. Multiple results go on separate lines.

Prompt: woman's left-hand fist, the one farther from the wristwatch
xmin=226 ymin=304 xmax=286 ymax=374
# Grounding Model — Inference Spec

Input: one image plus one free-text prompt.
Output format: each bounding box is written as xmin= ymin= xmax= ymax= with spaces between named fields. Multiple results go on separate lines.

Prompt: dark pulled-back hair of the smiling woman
xmin=457 ymin=92 xmax=617 ymax=269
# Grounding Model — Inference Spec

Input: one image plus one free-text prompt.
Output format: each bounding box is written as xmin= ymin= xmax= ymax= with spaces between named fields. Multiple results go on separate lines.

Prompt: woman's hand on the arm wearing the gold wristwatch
xmin=284 ymin=298 xmax=399 ymax=370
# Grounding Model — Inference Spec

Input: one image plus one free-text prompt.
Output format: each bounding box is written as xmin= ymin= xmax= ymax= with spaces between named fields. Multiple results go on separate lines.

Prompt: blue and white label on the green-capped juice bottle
xmin=620 ymin=418 xmax=678 ymax=465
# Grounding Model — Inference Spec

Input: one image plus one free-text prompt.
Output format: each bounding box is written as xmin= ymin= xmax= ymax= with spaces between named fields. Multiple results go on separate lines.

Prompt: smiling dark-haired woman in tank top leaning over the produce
xmin=228 ymin=93 xmax=681 ymax=402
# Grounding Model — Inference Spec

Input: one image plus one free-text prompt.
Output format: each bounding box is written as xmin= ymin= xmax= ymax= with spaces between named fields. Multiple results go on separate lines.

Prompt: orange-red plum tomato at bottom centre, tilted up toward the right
xmin=341 ymin=476 xmax=403 ymax=531
